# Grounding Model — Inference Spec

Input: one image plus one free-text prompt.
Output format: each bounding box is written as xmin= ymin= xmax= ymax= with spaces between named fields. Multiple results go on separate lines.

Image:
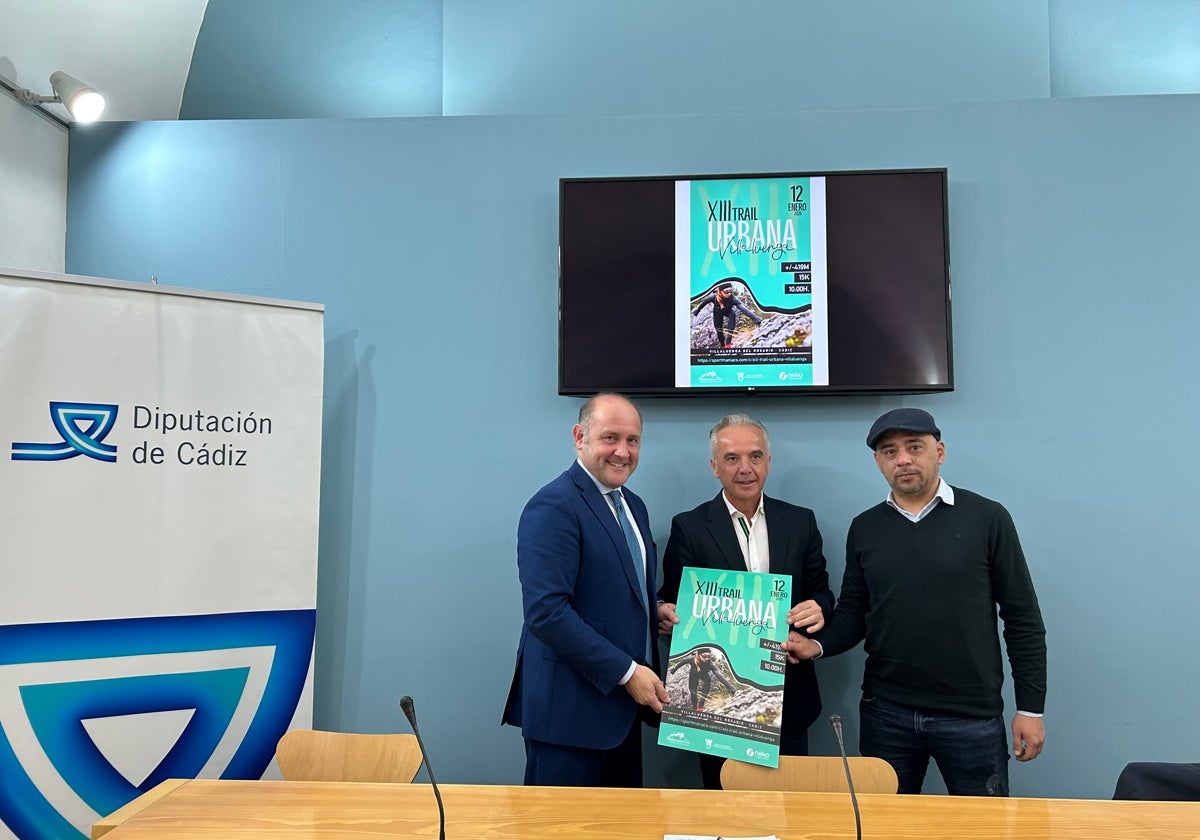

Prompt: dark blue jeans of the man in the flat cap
xmin=858 ymin=695 xmax=1008 ymax=797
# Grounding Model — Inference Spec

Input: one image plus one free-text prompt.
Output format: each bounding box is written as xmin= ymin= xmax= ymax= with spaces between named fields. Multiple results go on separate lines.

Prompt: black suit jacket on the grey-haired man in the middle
xmin=659 ymin=493 xmax=834 ymax=746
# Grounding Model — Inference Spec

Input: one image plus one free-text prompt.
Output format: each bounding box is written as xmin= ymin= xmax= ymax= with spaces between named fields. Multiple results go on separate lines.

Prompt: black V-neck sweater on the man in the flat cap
xmin=815 ymin=487 xmax=1046 ymax=718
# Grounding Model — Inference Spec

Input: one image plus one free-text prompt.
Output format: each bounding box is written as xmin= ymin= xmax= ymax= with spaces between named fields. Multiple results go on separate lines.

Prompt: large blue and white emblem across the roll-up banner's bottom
xmin=0 ymin=610 xmax=316 ymax=840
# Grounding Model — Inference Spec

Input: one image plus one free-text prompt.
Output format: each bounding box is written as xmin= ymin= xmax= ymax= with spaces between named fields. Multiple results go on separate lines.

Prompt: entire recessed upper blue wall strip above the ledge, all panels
xmin=180 ymin=0 xmax=1200 ymax=119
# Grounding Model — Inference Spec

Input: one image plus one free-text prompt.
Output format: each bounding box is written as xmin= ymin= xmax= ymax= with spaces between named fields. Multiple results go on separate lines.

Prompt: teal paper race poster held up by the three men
xmin=659 ymin=566 xmax=792 ymax=767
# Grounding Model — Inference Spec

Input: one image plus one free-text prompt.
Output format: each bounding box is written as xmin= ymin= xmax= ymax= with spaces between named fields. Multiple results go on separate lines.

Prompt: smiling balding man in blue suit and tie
xmin=503 ymin=394 xmax=667 ymax=787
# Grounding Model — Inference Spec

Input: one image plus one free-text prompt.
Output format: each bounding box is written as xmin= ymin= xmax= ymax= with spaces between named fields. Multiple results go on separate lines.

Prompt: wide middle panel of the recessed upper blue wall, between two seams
xmin=443 ymin=0 xmax=1050 ymax=114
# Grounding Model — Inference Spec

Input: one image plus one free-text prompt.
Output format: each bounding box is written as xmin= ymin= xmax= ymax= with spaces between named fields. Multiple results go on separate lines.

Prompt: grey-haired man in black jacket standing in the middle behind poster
xmin=659 ymin=414 xmax=834 ymax=788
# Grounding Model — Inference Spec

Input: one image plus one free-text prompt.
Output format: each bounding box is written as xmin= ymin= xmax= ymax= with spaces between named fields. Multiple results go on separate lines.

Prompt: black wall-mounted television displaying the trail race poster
xmin=558 ymin=168 xmax=954 ymax=396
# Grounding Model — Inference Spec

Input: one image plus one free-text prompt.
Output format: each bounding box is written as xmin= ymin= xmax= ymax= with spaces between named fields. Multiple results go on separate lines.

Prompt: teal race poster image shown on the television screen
xmin=676 ymin=176 xmax=828 ymax=388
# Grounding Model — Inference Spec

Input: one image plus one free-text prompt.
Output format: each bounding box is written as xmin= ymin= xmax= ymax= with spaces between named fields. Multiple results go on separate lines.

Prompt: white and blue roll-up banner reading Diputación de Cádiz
xmin=0 ymin=269 xmax=324 ymax=840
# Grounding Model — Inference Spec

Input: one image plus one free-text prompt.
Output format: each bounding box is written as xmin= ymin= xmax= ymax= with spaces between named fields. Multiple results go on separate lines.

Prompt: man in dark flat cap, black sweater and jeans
xmin=787 ymin=408 xmax=1046 ymax=796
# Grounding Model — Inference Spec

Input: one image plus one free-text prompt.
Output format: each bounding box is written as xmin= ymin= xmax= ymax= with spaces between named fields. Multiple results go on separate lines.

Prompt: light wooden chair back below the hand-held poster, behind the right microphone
xmin=721 ymin=756 xmax=900 ymax=793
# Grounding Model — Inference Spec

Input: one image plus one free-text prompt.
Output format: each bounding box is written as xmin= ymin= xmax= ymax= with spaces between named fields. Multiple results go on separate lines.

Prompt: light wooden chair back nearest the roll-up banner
xmin=275 ymin=730 xmax=421 ymax=784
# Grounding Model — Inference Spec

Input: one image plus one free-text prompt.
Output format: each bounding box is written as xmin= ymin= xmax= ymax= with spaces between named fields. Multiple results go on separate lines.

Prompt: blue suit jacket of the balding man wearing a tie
xmin=504 ymin=462 xmax=658 ymax=749
